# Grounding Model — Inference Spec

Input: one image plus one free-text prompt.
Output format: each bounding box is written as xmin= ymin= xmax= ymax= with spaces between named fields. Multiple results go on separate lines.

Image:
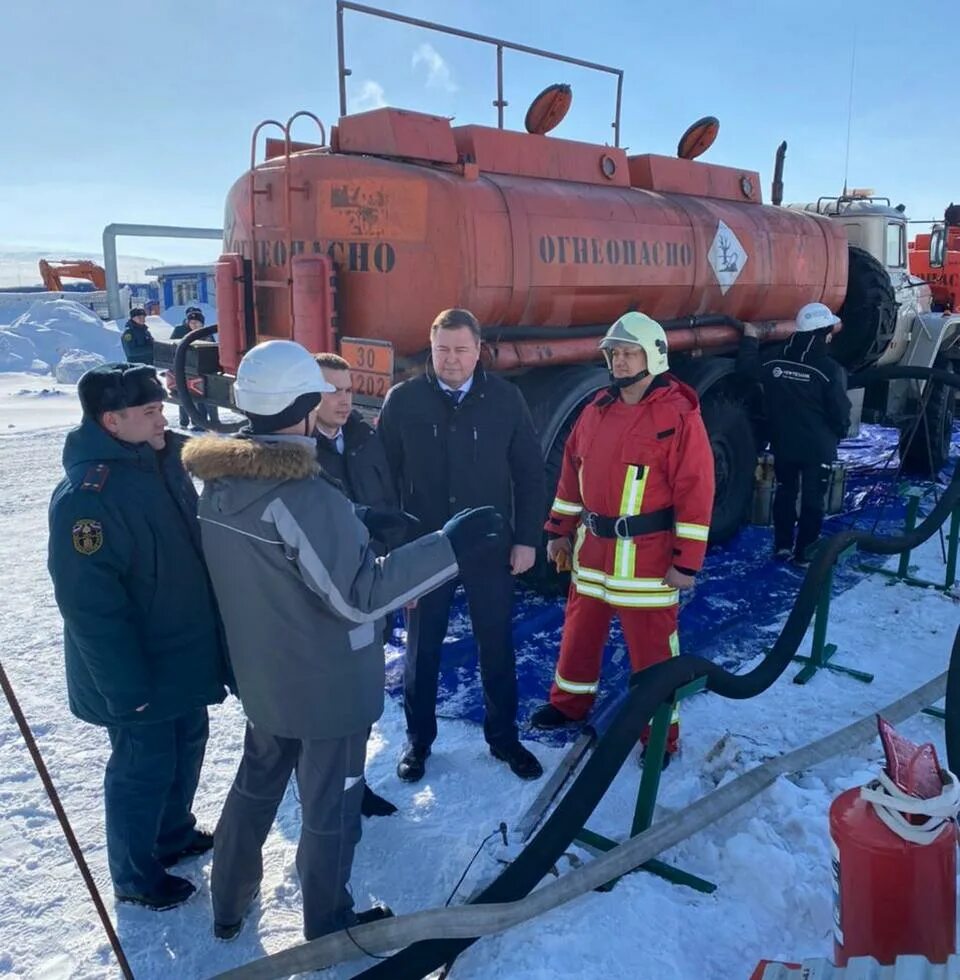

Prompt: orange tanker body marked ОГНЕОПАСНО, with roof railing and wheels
xmin=157 ymin=0 xmax=960 ymax=552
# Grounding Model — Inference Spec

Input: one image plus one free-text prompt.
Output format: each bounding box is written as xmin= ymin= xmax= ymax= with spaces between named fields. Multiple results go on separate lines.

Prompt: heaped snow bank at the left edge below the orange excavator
xmin=0 ymin=299 xmax=123 ymax=372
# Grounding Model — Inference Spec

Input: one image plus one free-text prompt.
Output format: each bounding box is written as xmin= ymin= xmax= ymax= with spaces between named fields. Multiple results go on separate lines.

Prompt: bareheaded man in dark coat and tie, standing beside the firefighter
xmin=378 ymin=309 xmax=545 ymax=782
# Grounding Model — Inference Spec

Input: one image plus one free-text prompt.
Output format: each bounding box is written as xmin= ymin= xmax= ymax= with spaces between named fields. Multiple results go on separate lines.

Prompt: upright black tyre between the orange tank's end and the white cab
xmin=830 ymin=245 xmax=897 ymax=371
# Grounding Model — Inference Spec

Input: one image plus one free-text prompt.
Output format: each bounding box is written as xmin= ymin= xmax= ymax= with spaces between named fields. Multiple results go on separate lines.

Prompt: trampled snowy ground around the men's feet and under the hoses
xmin=0 ymin=374 xmax=960 ymax=980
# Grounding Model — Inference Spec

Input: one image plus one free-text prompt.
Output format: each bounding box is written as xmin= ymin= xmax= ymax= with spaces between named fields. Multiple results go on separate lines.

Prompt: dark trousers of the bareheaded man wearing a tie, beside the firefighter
xmin=403 ymin=555 xmax=517 ymax=748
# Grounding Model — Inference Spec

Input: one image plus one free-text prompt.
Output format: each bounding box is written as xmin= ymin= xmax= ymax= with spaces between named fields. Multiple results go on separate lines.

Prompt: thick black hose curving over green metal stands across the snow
xmin=357 ymin=367 xmax=960 ymax=980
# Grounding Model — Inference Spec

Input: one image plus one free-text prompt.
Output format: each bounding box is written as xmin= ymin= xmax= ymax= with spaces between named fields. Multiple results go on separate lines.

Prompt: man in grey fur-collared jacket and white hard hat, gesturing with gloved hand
xmin=184 ymin=340 xmax=505 ymax=940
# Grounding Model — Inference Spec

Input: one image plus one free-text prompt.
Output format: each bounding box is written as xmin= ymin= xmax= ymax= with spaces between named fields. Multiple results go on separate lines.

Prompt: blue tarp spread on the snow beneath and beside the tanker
xmin=387 ymin=425 xmax=960 ymax=741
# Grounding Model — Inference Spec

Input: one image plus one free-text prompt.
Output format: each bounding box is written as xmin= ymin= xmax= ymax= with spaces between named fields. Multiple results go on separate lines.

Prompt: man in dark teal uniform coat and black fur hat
xmin=49 ymin=364 xmax=229 ymax=910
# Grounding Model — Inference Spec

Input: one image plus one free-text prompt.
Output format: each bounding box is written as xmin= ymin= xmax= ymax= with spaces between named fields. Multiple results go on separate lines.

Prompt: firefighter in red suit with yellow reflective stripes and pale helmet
xmin=531 ymin=313 xmax=714 ymax=753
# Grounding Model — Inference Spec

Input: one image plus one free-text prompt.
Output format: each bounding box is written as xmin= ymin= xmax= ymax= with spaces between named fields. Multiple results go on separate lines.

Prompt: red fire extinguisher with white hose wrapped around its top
xmin=830 ymin=719 xmax=960 ymax=966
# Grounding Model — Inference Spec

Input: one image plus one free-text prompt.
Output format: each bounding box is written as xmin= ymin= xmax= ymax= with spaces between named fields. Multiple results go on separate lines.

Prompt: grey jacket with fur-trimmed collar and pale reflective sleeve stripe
xmin=184 ymin=436 xmax=458 ymax=738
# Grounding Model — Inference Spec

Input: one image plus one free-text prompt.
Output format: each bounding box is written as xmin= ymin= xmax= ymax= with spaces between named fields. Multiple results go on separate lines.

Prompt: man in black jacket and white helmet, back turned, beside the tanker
xmin=737 ymin=303 xmax=850 ymax=568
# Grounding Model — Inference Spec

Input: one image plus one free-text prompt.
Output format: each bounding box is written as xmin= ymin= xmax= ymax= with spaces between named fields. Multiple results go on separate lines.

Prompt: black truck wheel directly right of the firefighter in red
xmin=702 ymin=393 xmax=757 ymax=544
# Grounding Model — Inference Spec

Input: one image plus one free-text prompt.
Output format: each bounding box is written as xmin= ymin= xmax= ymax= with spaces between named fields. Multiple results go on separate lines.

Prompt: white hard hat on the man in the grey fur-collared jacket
xmin=233 ymin=340 xmax=337 ymax=415
